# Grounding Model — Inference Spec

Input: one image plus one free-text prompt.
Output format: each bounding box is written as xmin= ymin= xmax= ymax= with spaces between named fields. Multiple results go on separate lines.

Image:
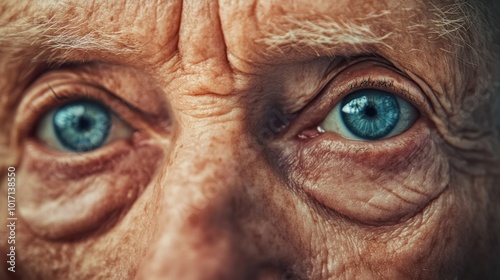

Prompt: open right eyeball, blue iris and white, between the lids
xmin=318 ymin=88 xmax=418 ymax=141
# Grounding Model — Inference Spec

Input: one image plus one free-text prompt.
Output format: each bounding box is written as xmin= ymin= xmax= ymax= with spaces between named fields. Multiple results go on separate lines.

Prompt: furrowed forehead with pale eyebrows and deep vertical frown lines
xmin=0 ymin=0 xmax=470 ymax=111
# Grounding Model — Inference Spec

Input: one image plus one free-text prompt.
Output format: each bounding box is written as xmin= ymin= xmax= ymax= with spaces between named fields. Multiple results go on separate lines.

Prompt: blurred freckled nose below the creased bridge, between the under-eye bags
xmin=136 ymin=130 xmax=281 ymax=280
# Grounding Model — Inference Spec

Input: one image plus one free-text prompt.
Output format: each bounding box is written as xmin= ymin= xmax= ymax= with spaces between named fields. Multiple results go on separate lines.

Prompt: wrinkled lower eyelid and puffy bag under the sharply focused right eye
xmin=278 ymin=120 xmax=449 ymax=225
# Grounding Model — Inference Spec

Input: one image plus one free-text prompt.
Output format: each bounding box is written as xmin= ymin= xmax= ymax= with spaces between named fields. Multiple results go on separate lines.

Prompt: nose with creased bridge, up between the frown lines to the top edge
xmin=133 ymin=1 xmax=308 ymax=279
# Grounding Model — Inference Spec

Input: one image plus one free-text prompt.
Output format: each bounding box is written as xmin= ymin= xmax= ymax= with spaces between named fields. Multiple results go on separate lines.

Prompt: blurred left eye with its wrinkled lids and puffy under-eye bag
xmin=12 ymin=63 xmax=169 ymax=239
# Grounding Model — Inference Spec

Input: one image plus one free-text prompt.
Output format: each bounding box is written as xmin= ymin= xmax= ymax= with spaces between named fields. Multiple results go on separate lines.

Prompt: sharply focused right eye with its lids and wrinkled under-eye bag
xmin=269 ymin=58 xmax=449 ymax=225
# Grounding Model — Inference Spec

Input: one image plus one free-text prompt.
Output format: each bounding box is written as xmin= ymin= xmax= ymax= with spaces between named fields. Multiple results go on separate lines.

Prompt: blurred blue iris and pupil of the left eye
xmin=52 ymin=101 xmax=111 ymax=152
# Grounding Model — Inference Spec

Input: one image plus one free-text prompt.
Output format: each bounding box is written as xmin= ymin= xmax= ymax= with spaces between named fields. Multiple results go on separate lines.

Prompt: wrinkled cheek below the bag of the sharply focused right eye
xmin=302 ymin=176 xmax=487 ymax=279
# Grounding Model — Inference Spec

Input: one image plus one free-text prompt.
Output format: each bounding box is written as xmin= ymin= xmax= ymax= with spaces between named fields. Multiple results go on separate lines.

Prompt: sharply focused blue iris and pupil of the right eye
xmin=341 ymin=89 xmax=400 ymax=140
